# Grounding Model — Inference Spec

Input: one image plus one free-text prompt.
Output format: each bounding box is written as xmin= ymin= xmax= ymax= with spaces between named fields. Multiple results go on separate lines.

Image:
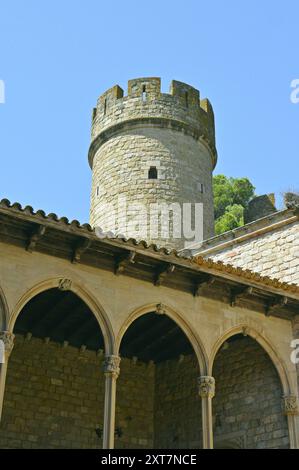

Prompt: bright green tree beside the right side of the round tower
xmin=213 ymin=175 xmax=255 ymax=235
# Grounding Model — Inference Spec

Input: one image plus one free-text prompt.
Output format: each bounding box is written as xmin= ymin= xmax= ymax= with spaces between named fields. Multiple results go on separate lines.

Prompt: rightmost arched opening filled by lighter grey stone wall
xmin=213 ymin=334 xmax=289 ymax=449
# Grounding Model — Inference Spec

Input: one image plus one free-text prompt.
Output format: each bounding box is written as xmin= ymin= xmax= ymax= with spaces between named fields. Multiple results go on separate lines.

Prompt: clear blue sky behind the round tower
xmin=0 ymin=0 xmax=299 ymax=222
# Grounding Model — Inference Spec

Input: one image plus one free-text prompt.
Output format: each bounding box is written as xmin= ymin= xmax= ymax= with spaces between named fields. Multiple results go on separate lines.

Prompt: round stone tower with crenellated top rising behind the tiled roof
xmin=89 ymin=78 xmax=217 ymax=249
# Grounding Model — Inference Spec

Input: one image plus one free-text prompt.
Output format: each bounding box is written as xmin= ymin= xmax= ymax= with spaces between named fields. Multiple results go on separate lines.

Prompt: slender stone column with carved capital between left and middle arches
xmin=103 ymin=355 xmax=120 ymax=449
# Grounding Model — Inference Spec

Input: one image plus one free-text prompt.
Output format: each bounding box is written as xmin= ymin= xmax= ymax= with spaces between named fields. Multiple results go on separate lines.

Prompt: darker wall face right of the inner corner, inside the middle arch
xmin=155 ymin=356 xmax=202 ymax=449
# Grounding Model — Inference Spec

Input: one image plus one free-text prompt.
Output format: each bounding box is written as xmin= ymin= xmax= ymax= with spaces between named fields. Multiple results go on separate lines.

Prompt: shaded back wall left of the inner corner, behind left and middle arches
xmin=0 ymin=336 xmax=153 ymax=448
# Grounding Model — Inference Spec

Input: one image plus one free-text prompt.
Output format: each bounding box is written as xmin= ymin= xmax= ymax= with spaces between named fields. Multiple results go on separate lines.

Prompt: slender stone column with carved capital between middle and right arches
xmin=198 ymin=375 xmax=215 ymax=449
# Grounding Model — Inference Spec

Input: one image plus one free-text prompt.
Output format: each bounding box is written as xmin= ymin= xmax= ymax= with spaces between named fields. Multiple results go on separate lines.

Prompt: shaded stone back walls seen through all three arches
xmin=0 ymin=336 xmax=289 ymax=449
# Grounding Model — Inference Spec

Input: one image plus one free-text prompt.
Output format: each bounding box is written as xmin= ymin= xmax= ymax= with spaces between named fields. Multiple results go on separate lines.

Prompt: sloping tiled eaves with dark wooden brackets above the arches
xmin=0 ymin=200 xmax=299 ymax=310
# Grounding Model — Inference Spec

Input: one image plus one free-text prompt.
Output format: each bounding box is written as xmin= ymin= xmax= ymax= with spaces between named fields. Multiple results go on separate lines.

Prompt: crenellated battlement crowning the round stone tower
xmin=90 ymin=77 xmax=216 ymax=169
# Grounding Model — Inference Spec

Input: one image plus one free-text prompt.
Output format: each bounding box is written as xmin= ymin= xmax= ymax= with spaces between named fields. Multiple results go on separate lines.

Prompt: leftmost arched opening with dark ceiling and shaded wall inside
xmin=0 ymin=288 xmax=104 ymax=448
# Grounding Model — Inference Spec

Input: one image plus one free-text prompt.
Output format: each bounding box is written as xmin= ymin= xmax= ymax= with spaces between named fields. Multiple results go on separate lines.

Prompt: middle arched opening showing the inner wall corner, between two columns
xmin=115 ymin=312 xmax=202 ymax=449
